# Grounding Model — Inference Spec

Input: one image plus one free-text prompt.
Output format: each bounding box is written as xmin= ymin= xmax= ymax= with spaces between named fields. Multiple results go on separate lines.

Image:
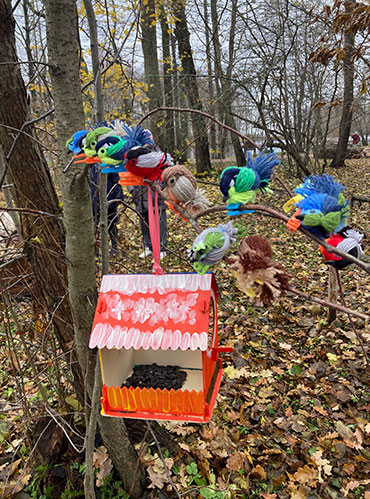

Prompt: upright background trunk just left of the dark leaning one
xmin=140 ymin=0 xmax=166 ymax=149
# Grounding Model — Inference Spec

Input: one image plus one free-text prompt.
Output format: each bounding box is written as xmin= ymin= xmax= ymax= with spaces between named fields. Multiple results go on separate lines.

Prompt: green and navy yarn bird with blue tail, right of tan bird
xmin=220 ymin=153 xmax=280 ymax=215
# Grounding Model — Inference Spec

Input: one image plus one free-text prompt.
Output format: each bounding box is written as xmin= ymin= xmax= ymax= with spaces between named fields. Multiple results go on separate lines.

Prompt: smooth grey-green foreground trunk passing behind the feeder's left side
xmin=45 ymin=0 xmax=145 ymax=497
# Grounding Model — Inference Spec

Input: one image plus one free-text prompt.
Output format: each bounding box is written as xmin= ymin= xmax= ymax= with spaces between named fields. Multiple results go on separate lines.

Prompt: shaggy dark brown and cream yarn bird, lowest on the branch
xmin=230 ymin=236 xmax=289 ymax=306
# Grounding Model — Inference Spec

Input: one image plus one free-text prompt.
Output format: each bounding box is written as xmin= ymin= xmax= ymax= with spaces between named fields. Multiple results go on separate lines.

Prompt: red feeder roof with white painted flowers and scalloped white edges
xmin=89 ymin=273 xmax=218 ymax=351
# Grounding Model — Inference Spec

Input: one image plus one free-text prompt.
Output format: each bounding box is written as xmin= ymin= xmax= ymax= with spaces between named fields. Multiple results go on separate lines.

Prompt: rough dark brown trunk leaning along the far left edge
xmin=0 ymin=0 xmax=84 ymax=401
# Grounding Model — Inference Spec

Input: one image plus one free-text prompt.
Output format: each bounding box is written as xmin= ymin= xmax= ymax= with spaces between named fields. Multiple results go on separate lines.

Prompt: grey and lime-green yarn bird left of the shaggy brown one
xmin=188 ymin=221 xmax=238 ymax=274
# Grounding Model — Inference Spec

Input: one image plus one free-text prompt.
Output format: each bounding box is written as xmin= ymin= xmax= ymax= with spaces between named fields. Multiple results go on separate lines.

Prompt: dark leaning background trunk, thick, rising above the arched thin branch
xmin=172 ymin=2 xmax=211 ymax=173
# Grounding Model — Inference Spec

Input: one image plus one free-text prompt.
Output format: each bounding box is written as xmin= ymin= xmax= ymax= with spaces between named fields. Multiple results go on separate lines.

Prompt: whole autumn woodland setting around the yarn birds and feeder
xmin=0 ymin=0 xmax=370 ymax=499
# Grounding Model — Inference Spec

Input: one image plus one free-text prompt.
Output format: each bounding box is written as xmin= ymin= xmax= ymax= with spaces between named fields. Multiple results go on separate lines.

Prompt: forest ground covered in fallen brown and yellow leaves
xmin=0 ymin=159 xmax=370 ymax=499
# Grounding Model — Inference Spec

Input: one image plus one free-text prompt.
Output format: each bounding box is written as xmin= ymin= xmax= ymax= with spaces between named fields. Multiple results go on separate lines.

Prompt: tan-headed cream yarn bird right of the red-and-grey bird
xmin=162 ymin=165 xmax=212 ymax=215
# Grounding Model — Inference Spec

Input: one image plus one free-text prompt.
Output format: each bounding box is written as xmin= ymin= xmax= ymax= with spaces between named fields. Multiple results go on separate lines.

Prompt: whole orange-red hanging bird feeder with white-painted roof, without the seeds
xmin=89 ymin=273 xmax=232 ymax=423
